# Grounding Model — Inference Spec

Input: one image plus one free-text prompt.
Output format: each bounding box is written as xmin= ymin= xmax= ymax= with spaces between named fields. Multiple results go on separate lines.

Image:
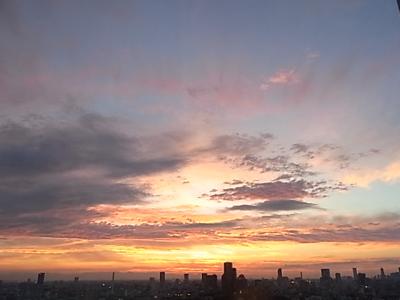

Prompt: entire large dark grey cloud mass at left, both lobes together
xmin=0 ymin=114 xmax=185 ymax=222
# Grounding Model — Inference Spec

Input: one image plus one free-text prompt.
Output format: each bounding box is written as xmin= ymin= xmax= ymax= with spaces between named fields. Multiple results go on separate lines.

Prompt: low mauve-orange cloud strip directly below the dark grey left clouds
xmin=0 ymin=209 xmax=240 ymax=241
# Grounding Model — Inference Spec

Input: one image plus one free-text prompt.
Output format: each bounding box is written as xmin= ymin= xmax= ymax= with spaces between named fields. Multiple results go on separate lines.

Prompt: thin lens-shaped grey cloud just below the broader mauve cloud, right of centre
xmin=228 ymin=200 xmax=318 ymax=212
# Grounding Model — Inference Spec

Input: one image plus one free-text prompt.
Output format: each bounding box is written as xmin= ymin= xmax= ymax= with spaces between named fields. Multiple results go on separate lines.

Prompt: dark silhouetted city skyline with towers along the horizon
xmin=0 ymin=262 xmax=400 ymax=300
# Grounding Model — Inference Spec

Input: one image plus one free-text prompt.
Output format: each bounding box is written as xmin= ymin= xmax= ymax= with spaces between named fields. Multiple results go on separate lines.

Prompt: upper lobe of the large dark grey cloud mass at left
xmin=0 ymin=115 xmax=182 ymax=178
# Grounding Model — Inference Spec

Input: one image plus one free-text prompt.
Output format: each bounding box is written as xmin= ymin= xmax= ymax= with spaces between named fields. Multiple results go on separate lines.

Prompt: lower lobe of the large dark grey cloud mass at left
xmin=0 ymin=176 xmax=148 ymax=215
